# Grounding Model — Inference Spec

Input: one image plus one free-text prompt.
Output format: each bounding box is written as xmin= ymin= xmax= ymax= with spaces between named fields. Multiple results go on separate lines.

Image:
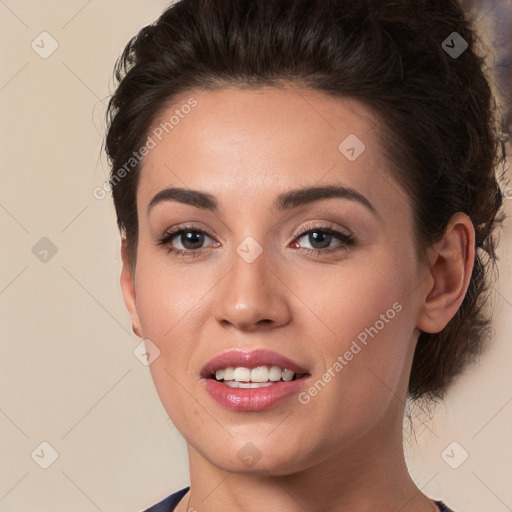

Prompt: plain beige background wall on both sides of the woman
xmin=0 ymin=0 xmax=512 ymax=512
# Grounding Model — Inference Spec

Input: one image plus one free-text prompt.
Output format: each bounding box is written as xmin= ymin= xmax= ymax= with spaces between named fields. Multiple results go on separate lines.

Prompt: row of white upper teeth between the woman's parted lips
xmin=215 ymin=366 xmax=295 ymax=388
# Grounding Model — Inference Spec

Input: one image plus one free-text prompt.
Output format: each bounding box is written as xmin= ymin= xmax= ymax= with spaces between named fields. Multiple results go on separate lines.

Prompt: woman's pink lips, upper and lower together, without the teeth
xmin=201 ymin=349 xmax=309 ymax=412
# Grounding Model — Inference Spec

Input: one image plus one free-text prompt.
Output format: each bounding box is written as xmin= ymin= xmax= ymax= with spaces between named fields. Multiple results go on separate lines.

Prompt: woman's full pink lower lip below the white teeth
xmin=204 ymin=377 xmax=308 ymax=412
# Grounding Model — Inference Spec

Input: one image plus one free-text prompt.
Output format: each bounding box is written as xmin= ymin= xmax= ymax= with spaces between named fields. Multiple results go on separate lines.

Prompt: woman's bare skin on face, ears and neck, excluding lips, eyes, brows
xmin=121 ymin=87 xmax=474 ymax=512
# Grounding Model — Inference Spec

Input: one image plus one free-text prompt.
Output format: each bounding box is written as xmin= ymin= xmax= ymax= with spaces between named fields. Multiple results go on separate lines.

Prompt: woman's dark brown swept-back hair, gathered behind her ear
xmin=105 ymin=0 xmax=502 ymax=398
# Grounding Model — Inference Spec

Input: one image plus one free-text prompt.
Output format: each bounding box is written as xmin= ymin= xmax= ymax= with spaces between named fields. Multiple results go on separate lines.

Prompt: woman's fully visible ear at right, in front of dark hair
xmin=417 ymin=212 xmax=475 ymax=333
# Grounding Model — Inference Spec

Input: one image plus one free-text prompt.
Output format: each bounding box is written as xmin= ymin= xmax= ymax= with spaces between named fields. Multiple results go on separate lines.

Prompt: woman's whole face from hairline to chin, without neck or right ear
xmin=122 ymin=88 xmax=424 ymax=474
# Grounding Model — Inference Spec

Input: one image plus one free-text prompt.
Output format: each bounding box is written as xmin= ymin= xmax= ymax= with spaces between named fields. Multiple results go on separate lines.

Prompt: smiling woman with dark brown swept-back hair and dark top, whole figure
xmin=106 ymin=0 xmax=502 ymax=512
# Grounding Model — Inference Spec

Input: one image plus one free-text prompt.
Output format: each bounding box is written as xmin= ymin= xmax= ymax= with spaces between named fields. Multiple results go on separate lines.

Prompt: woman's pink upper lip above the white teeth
xmin=201 ymin=349 xmax=307 ymax=378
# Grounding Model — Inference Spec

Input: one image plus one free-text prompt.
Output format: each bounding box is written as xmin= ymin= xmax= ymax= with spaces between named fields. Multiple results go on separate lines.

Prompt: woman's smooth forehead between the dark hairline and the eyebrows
xmin=138 ymin=87 xmax=406 ymax=215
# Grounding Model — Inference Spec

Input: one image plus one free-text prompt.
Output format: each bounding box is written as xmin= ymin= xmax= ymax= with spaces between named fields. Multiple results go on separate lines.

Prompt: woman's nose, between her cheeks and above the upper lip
xmin=214 ymin=243 xmax=291 ymax=332
